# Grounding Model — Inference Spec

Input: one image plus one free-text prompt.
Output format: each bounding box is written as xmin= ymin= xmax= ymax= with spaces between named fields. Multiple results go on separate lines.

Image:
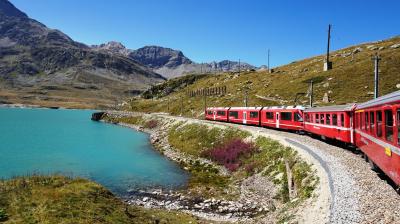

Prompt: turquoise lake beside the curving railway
xmin=0 ymin=107 xmax=188 ymax=196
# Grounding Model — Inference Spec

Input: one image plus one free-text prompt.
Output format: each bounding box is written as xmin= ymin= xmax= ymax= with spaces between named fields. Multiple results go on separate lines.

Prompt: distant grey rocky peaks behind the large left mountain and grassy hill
xmin=92 ymin=41 xmax=257 ymax=78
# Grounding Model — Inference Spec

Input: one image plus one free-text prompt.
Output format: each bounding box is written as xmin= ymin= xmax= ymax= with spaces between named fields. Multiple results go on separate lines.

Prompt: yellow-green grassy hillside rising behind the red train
xmin=129 ymin=37 xmax=400 ymax=116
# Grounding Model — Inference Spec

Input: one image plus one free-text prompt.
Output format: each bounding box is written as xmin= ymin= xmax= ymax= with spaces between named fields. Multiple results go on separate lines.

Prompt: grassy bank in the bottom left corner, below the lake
xmin=0 ymin=176 xmax=198 ymax=223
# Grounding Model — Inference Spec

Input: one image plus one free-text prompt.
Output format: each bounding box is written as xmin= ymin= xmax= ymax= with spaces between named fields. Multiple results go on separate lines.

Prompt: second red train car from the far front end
xmin=229 ymin=107 xmax=262 ymax=125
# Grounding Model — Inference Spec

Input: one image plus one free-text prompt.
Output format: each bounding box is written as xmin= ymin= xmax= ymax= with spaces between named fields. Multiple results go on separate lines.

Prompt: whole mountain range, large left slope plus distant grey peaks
xmin=0 ymin=0 xmax=255 ymax=108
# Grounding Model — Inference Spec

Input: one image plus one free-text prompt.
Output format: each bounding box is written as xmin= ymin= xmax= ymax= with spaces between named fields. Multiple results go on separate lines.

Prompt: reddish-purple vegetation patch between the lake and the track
xmin=203 ymin=139 xmax=255 ymax=172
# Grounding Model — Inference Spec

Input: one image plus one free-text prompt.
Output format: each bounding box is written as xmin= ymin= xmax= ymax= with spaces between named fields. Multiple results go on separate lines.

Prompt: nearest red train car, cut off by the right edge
xmin=355 ymin=91 xmax=400 ymax=186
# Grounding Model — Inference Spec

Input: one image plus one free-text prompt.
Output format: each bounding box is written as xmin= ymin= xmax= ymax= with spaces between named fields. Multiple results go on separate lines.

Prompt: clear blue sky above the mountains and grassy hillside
xmin=11 ymin=0 xmax=400 ymax=66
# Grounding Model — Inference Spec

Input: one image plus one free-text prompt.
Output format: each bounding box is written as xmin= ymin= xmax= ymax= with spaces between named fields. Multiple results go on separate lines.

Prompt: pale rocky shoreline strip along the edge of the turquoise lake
xmin=99 ymin=111 xmax=250 ymax=222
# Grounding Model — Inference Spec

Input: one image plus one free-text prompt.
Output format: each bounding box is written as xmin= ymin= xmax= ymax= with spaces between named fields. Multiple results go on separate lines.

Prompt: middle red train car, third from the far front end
xmin=261 ymin=106 xmax=304 ymax=131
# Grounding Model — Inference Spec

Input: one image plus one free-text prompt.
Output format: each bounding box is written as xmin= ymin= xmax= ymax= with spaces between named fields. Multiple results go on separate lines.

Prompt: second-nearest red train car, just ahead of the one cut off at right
xmin=304 ymin=104 xmax=355 ymax=144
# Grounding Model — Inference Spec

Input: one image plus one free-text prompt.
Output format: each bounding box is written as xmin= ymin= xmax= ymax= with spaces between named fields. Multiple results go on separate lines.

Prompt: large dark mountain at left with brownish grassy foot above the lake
xmin=0 ymin=0 xmax=165 ymax=107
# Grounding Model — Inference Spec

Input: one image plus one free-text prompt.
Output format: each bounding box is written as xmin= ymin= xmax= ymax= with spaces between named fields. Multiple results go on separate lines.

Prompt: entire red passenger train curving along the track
xmin=205 ymin=91 xmax=400 ymax=186
